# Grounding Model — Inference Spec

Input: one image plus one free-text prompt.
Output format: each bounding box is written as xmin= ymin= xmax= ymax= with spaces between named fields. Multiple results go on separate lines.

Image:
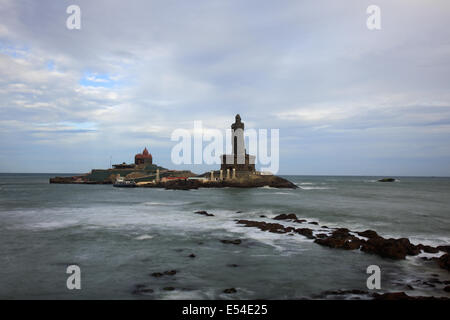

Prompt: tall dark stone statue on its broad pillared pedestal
xmin=220 ymin=114 xmax=256 ymax=180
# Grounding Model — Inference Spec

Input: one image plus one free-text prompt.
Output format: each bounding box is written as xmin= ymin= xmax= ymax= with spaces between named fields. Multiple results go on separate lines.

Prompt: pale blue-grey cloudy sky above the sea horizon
xmin=0 ymin=0 xmax=450 ymax=176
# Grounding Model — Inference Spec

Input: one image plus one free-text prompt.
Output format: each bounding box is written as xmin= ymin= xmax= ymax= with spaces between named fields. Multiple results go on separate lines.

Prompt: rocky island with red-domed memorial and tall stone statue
xmin=50 ymin=114 xmax=298 ymax=190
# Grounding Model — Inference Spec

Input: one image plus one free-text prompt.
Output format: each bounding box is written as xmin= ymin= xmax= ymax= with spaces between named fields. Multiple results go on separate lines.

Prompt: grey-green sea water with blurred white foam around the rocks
xmin=0 ymin=174 xmax=450 ymax=299
